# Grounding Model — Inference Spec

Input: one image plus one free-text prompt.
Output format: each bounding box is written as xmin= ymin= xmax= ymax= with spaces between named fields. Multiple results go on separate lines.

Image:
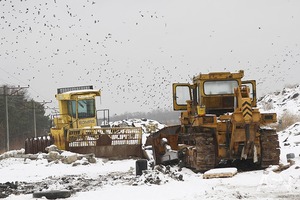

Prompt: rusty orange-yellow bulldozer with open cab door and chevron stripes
xmin=147 ymin=70 xmax=280 ymax=171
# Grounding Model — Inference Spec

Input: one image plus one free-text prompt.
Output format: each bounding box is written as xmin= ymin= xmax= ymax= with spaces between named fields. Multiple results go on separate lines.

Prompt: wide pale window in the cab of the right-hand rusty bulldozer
xmin=204 ymin=80 xmax=238 ymax=95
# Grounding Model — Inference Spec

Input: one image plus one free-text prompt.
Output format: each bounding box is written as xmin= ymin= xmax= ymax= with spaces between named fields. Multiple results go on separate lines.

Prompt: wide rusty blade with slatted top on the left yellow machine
xmin=67 ymin=127 xmax=142 ymax=159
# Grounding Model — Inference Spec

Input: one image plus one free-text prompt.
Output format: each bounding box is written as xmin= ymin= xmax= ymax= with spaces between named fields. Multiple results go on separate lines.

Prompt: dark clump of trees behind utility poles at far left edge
xmin=0 ymin=85 xmax=51 ymax=153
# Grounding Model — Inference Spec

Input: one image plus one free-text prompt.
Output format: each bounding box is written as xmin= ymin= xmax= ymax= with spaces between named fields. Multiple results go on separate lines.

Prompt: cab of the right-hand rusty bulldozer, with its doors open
xmin=173 ymin=70 xmax=256 ymax=116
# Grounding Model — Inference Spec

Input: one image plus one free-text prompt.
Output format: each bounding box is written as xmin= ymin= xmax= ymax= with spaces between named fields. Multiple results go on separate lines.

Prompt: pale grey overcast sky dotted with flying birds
xmin=0 ymin=0 xmax=300 ymax=115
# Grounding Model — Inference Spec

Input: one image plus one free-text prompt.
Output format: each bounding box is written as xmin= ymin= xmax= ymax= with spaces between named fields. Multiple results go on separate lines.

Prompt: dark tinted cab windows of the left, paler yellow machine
xmin=68 ymin=99 xmax=95 ymax=119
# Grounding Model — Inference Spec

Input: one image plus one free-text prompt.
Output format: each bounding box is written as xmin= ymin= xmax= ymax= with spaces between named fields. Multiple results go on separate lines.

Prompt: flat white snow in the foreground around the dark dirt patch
xmin=0 ymin=151 xmax=300 ymax=200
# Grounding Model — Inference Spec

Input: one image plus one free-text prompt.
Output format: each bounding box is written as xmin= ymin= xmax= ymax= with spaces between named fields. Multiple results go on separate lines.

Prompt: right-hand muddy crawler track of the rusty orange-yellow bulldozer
xmin=260 ymin=129 xmax=280 ymax=168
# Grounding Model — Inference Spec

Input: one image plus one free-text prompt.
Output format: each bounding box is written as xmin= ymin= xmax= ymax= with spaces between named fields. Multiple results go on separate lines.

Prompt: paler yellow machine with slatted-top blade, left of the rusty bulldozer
xmin=25 ymin=86 xmax=142 ymax=159
